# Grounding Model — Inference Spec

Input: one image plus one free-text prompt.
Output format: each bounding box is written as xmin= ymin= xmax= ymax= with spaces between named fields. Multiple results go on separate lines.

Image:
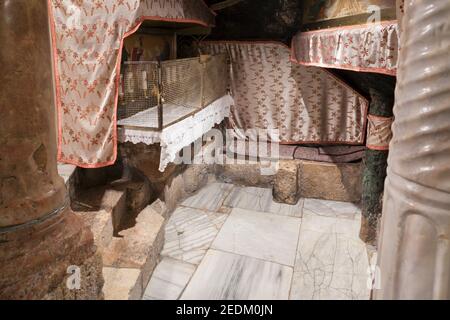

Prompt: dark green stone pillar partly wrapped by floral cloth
xmin=360 ymin=88 xmax=394 ymax=245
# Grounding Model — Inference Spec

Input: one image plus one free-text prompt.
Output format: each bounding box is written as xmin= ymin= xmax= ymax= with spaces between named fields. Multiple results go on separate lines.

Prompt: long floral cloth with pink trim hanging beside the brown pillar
xmin=48 ymin=0 xmax=214 ymax=168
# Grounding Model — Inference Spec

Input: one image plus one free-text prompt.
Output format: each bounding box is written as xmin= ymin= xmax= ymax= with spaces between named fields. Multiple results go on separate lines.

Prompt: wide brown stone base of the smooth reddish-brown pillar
xmin=0 ymin=208 xmax=103 ymax=300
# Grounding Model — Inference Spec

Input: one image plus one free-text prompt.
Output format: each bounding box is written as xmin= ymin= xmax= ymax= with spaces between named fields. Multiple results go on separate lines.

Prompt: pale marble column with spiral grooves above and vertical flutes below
xmin=374 ymin=0 xmax=450 ymax=299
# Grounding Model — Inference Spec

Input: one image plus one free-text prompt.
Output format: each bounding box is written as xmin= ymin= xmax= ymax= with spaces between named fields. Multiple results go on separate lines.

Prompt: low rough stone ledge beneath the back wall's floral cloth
xmin=216 ymin=160 xmax=362 ymax=204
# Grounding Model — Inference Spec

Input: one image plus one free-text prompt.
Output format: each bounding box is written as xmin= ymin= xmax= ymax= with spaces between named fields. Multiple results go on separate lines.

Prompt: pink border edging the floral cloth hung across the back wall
xmin=203 ymin=40 xmax=369 ymax=146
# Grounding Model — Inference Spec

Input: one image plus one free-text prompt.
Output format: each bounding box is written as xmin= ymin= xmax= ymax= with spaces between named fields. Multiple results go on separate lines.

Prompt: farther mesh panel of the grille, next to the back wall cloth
xmin=202 ymin=54 xmax=229 ymax=107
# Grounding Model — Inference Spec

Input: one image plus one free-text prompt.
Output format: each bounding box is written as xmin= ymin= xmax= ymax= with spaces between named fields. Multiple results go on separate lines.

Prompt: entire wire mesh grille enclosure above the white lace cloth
xmin=118 ymin=55 xmax=229 ymax=130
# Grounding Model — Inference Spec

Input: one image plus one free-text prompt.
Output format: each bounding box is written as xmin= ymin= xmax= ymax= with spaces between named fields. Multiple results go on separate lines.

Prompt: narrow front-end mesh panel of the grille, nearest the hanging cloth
xmin=118 ymin=62 xmax=159 ymax=120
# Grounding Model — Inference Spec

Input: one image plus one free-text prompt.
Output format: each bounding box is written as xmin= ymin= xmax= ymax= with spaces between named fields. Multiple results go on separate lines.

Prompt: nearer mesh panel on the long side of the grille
xmin=161 ymin=58 xmax=202 ymax=108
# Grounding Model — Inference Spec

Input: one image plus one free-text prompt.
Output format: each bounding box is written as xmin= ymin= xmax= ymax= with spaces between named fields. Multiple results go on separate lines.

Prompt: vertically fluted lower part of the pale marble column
xmin=374 ymin=172 xmax=450 ymax=300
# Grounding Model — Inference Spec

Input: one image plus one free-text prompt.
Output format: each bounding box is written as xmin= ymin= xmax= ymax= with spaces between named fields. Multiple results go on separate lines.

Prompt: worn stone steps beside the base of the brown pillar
xmin=72 ymin=171 xmax=167 ymax=300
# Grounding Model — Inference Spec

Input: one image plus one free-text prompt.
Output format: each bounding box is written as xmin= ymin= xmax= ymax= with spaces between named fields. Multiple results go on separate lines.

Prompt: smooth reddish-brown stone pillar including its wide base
xmin=0 ymin=0 xmax=103 ymax=299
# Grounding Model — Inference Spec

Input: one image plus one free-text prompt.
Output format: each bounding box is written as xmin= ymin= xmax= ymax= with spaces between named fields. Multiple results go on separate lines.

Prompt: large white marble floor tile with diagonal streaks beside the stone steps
xmin=161 ymin=207 xmax=228 ymax=264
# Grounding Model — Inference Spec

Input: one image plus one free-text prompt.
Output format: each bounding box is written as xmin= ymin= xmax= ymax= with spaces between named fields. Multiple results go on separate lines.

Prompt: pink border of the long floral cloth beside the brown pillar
xmin=47 ymin=0 xmax=217 ymax=169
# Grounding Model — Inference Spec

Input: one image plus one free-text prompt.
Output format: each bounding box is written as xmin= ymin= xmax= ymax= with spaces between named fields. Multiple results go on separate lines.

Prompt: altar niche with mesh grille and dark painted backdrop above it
xmin=118 ymin=29 xmax=228 ymax=131
